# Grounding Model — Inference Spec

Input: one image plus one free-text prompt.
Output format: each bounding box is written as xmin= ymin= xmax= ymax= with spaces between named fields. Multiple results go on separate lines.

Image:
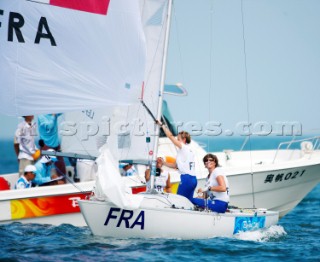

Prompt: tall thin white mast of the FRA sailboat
xmin=150 ymin=0 xmax=173 ymax=189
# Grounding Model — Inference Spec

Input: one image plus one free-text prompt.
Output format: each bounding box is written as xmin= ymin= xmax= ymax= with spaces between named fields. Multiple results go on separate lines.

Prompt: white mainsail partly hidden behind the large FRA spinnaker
xmin=62 ymin=0 xmax=168 ymax=159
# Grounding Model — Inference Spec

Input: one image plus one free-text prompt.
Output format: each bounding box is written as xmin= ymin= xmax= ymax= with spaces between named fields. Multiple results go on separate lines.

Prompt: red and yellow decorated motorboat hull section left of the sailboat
xmin=0 ymin=181 xmax=94 ymax=226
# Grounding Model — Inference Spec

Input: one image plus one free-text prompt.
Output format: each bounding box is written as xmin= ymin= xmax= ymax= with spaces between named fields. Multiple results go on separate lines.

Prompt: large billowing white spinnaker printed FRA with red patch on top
xmin=0 ymin=0 xmax=146 ymax=116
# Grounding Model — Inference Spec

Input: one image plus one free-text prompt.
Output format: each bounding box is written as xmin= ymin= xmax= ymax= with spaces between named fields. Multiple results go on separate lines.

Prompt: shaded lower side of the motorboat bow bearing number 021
xmin=199 ymin=160 xmax=320 ymax=217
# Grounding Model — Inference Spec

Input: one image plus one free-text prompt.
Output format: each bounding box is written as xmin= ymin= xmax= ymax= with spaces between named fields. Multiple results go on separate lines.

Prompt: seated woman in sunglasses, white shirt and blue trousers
xmin=193 ymin=154 xmax=229 ymax=213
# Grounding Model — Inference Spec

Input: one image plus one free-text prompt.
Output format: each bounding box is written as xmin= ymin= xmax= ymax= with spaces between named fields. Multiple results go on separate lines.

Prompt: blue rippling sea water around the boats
xmin=0 ymin=138 xmax=320 ymax=262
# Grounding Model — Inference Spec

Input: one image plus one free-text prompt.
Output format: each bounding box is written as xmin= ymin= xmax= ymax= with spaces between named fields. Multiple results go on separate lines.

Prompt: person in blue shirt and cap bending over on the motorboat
xmin=33 ymin=156 xmax=58 ymax=185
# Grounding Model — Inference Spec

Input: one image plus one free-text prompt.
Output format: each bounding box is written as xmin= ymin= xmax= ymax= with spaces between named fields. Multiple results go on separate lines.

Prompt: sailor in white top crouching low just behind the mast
xmin=145 ymin=157 xmax=171 ymax=193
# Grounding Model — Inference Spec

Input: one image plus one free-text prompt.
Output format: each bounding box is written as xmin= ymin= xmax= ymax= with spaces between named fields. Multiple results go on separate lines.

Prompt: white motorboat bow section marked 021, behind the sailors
xmin=159 ymin=137 xmax=320 ymax=218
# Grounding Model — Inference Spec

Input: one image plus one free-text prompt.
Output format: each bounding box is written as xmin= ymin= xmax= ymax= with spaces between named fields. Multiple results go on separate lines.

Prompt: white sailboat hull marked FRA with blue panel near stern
xmin=79 ymin=194 xmax=279 ymax=239
